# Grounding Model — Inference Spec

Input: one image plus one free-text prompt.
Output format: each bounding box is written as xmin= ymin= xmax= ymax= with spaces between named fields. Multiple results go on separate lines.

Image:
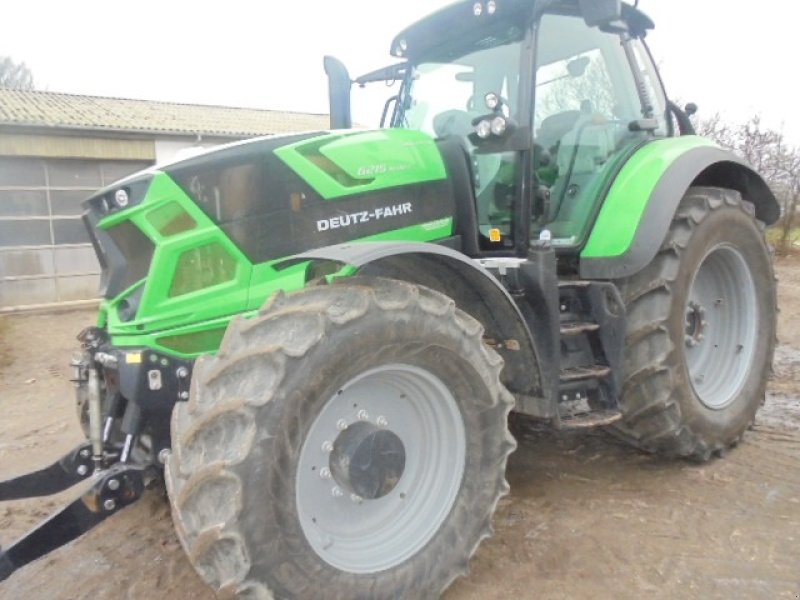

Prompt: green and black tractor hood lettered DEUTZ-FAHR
xmin=84 ymin=129 xmax=454 ymax=356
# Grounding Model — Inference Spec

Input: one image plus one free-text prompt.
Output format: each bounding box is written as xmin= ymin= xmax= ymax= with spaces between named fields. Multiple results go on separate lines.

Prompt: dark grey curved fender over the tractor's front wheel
xmin=291 ymin=242 xmax=549 ymax=414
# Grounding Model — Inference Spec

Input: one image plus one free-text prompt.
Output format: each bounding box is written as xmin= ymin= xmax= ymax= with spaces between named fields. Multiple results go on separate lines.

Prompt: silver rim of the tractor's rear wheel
xmin=684 ymin=244 xmax=758 ymax=410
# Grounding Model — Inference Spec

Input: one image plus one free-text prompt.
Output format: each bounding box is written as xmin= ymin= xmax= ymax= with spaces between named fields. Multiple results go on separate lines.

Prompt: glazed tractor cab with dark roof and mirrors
xmin=327 ymin=0 xmax=673 ymax=256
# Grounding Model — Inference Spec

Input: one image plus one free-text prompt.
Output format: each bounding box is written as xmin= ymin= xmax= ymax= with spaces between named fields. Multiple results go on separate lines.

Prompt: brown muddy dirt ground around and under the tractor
xmin=0 ymin=257 xmax=800 ymax=600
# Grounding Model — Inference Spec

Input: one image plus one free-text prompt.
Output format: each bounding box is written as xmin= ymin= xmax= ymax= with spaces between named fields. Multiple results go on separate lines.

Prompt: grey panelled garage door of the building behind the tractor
xmin=0 ymin=157 xmax=150 ymax=310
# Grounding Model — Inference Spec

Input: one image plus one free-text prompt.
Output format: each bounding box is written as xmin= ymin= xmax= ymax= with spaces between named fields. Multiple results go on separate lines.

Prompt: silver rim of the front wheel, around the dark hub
xmin=295 ymin=364 xmax=466 ymax=574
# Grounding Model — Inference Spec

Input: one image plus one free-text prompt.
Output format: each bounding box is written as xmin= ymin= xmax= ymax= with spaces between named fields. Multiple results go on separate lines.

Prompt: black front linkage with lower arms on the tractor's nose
xmin=0 ymin=327 xmax=192 ymax=581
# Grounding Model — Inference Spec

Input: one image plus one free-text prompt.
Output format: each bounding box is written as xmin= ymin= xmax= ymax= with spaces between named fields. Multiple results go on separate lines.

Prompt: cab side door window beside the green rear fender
xmin=532 ymin=14 xmax=652 ymax=246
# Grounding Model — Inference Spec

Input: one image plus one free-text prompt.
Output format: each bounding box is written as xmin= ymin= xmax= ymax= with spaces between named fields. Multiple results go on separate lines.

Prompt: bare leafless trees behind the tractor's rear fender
xmin=696 ymin=114 xmax=800 ymax=250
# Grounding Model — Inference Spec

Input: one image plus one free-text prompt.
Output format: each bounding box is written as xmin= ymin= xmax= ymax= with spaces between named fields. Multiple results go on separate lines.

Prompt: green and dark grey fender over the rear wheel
xmin=580 ymin=136 xmax=780 ymax=279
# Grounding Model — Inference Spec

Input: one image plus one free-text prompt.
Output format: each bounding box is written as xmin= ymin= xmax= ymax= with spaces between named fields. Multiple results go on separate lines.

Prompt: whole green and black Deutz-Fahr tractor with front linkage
xmin=0 ymin=0 xmax=779 ymax=598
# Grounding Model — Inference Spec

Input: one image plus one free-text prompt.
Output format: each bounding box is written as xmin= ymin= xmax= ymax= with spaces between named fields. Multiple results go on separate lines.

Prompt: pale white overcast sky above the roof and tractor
xmin=0 ymin=0 xmax=800 ymax=144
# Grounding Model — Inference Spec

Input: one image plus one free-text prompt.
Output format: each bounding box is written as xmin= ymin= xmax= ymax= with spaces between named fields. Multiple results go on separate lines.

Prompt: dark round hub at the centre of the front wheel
xmin=330 ymin=421 xmax=406 ymax=500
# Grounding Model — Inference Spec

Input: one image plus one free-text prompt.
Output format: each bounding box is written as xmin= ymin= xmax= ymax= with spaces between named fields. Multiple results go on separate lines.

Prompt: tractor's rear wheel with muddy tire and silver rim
xmin=617 ymin=187 xmax=776 ymax=460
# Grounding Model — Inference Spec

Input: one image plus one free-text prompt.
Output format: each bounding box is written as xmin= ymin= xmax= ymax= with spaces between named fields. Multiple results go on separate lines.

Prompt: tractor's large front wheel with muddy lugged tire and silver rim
xmin=166 ymin=278 xmax=514 ymax=599
